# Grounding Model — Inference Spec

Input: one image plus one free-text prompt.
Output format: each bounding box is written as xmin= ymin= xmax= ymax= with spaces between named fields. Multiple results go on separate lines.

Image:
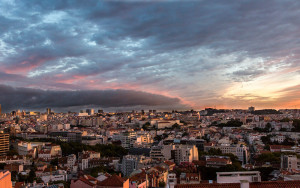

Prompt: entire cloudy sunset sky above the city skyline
xmin=0 ymin=0 xmax=300 ymax=110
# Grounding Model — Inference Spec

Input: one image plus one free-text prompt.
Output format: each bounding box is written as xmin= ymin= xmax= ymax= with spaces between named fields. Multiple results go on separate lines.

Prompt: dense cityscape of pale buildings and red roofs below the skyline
xmin=0 ymin=107 xmax=300 ymax=188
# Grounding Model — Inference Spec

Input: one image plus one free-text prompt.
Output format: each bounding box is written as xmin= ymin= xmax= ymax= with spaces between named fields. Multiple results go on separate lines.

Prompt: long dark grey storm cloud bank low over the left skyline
xmin=0 ymin=85 xmax=180 ymax=110
